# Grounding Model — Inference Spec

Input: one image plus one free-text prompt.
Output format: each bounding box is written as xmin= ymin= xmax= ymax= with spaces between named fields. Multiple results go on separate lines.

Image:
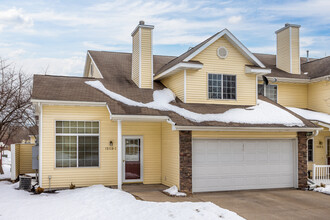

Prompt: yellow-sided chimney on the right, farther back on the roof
xmin=275 ymin=23 xmax=300 ymax=74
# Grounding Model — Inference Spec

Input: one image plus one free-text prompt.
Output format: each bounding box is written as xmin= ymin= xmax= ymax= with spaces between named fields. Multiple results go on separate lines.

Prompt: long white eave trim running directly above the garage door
xmin=174 ymin=125 xmax=322 ymax=132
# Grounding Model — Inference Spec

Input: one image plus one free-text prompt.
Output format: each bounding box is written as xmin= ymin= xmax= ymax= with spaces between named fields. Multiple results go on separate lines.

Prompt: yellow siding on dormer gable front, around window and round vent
xmin=186 ymin=37 xmax=256 ymax=105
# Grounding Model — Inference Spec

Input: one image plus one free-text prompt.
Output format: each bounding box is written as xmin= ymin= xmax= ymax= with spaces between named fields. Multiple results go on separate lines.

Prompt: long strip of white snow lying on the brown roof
xmin=85 ymin=81 xmax=304 ymax=126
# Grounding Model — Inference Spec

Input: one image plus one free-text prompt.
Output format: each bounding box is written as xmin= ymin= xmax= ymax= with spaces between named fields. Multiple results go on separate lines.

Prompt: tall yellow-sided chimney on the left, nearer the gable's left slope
xmin=131 ymin=21 xmax=154 ymax=89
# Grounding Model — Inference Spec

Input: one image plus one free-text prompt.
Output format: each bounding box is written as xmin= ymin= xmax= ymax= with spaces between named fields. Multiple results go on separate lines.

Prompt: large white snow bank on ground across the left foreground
xmin=0 ymin=182 xmax=243 ymax=220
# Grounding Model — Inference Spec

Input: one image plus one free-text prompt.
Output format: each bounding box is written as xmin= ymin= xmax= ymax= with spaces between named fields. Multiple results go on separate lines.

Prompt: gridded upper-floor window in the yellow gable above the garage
xmin=208 ymin=73 xmax=236 ymax=99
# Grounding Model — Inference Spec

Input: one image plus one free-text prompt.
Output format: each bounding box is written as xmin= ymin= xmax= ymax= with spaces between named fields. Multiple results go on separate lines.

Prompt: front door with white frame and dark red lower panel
xmin=123 ymin=136 xmax=143 ymax=182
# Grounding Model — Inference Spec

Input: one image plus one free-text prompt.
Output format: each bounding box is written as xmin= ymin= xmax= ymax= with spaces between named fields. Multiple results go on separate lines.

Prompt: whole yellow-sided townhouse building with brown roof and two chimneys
xmin=32 ymin=22 xmax=330 ymax=192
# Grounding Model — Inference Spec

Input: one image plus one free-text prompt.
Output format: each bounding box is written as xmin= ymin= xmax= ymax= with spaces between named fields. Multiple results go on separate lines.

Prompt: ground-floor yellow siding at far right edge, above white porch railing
xmin=308 ymin=127 xmax=330 ymax=170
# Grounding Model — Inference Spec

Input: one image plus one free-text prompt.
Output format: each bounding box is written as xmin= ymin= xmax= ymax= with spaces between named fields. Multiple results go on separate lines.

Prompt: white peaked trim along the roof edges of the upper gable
xmin=155 ymin=29 xmax=265 ymax=75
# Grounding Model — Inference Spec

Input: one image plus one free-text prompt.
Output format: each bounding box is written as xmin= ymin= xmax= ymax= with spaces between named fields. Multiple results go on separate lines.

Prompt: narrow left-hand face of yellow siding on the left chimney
xmin=132 ymin=31 xmax=140 ymax=86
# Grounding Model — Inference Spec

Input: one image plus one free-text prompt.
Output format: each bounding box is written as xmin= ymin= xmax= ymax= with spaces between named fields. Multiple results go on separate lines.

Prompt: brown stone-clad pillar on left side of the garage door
xmin=179 ymin=131 xmax=192 ymax=193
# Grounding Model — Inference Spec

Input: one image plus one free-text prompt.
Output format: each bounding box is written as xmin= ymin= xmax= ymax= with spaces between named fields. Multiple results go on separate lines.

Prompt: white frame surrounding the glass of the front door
xmin=122 ymin=135 xmax=143 ymax=183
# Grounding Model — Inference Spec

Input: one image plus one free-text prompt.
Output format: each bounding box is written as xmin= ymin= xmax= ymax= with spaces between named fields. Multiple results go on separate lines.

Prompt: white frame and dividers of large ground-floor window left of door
xmin=54 ymin=119 xmax=101 ymax=169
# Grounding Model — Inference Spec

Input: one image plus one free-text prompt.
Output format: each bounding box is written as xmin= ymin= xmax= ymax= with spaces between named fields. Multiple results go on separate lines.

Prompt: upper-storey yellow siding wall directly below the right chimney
xmin=276 ymin=83 xmax=308 ymax=108
